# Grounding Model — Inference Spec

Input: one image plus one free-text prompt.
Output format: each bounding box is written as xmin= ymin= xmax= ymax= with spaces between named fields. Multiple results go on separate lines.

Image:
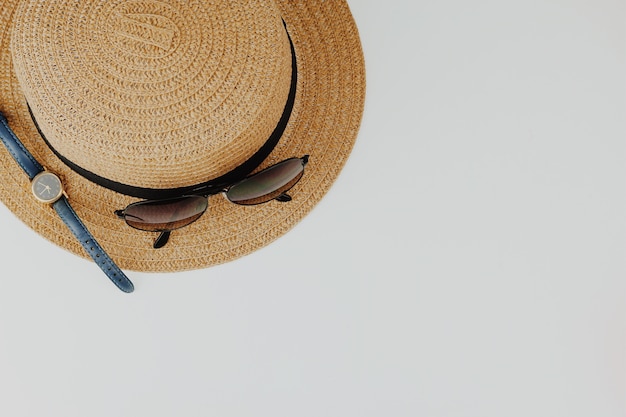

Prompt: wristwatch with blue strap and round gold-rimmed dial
xmin=0 ymin=113 xmax=135 ymax=293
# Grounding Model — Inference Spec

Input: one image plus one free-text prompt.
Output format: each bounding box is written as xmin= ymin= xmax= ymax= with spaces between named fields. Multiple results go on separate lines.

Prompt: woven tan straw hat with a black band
xmin=0 ymin=0 xmax=365 ymax=271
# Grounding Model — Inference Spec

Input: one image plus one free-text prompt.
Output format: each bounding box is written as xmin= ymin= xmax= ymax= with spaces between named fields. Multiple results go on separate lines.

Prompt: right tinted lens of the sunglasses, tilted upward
xmin=226 ymin=157 xmax=307 ymax=205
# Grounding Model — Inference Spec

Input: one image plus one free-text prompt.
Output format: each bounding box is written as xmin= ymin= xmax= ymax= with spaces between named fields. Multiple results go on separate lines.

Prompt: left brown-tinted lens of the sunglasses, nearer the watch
xmin=123 ymin=196 xmax=208 ymax=232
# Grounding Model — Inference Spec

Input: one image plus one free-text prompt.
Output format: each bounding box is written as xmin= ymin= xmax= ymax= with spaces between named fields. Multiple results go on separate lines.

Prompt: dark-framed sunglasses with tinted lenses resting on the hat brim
xmin=115 ymin=155 xmax=309 ymax=249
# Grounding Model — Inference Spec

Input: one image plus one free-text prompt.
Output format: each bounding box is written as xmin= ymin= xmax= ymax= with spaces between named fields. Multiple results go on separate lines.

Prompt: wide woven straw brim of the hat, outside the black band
xmin=0 ymin=0 xmax=365 ymax=272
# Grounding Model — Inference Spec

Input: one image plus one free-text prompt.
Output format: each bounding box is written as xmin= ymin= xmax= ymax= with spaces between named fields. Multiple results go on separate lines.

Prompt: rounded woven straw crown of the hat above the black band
xmin=11 ymin=0 xmax=291 ymax=188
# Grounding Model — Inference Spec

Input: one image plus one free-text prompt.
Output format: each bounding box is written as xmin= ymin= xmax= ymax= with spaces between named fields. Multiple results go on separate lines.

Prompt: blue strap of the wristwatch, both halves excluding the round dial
xmin=0 ymin=113 xmax=134 ymax=293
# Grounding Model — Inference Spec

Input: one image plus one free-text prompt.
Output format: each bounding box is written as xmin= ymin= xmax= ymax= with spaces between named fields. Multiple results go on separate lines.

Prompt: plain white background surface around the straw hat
xmin=0 ymin=0 xmax=626 ymax=417
